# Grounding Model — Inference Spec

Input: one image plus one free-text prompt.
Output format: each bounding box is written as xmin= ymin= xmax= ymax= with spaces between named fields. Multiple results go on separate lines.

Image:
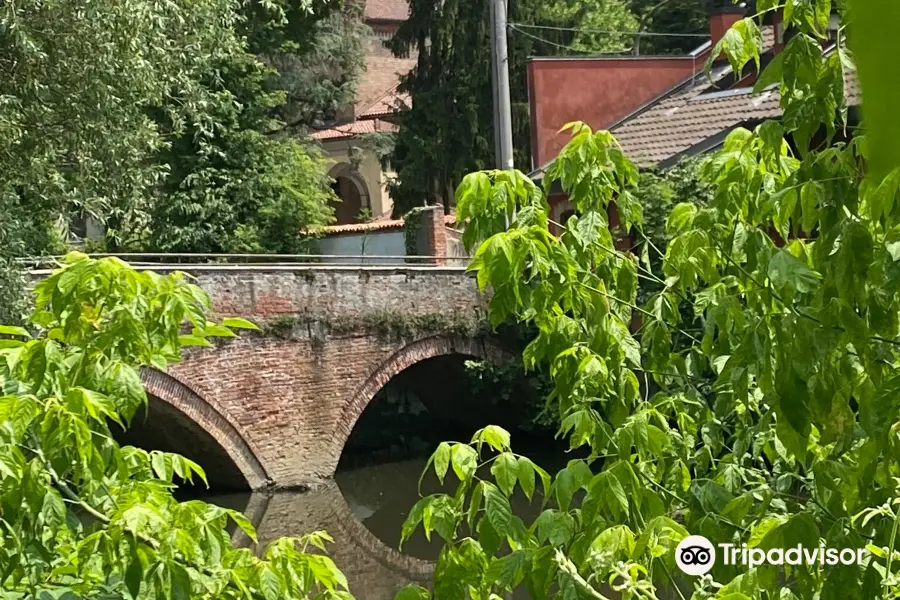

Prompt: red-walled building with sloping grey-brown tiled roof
xmin=528 ymin=7 xmax=859 ymax=234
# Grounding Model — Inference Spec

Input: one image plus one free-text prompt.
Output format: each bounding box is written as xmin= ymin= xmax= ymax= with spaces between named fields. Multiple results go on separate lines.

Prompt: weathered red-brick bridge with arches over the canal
xmin=116 ymin=265 xmax=503 ymax=490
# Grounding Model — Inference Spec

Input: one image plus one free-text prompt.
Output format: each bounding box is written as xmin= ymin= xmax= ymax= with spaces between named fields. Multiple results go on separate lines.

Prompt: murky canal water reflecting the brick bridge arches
xmin=206 ymin=453 xmax=567 ymax=600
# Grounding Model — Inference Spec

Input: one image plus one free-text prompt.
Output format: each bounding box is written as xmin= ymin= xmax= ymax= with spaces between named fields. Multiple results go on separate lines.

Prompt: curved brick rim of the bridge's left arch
xmin=141 ymin=368 xmax=270 ymax=490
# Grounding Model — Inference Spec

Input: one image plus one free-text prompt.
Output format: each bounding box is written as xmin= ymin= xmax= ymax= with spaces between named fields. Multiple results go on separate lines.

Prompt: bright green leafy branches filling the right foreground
xmin=403 ymin=1 xmax=900 ymax=600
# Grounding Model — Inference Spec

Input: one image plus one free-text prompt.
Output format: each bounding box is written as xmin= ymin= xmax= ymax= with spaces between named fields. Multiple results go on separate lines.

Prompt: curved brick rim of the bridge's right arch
xmin=331 ymin=335 xmax=510 ymax=466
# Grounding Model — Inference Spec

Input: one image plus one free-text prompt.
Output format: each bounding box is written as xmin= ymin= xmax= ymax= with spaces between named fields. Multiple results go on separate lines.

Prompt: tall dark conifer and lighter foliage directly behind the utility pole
xmin=391 ymin=0 xmax=636 ymax=215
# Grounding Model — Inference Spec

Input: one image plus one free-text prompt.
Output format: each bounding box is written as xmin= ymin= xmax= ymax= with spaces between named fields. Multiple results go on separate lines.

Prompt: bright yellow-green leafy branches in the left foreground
xmin=0 ymin=254 xmax=350 ymax=600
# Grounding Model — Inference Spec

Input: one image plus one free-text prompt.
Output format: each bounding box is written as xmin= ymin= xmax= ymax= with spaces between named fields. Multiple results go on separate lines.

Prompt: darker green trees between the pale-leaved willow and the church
xmin=121 ymin=0 xmax=364 ymax=253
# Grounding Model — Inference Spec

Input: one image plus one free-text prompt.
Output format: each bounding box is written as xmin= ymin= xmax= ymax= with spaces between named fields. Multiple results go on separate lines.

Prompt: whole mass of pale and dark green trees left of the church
xmin=0 ymin=0 xmax=365 ymax=252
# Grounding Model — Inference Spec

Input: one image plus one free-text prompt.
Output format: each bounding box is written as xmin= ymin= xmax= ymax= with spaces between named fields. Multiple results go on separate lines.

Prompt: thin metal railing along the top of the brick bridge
xmin=16 ymin=252 xmax=471 ymax=271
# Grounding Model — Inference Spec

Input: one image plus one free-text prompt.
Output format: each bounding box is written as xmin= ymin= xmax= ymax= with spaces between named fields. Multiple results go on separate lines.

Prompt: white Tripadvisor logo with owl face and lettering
xmin=675 ymin=535 xmax=869 ymax=576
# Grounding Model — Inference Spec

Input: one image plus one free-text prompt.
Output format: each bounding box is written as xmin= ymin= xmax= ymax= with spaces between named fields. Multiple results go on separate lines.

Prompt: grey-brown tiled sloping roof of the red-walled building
xmin=611 ymin=36 xmax=860 ymax=166
